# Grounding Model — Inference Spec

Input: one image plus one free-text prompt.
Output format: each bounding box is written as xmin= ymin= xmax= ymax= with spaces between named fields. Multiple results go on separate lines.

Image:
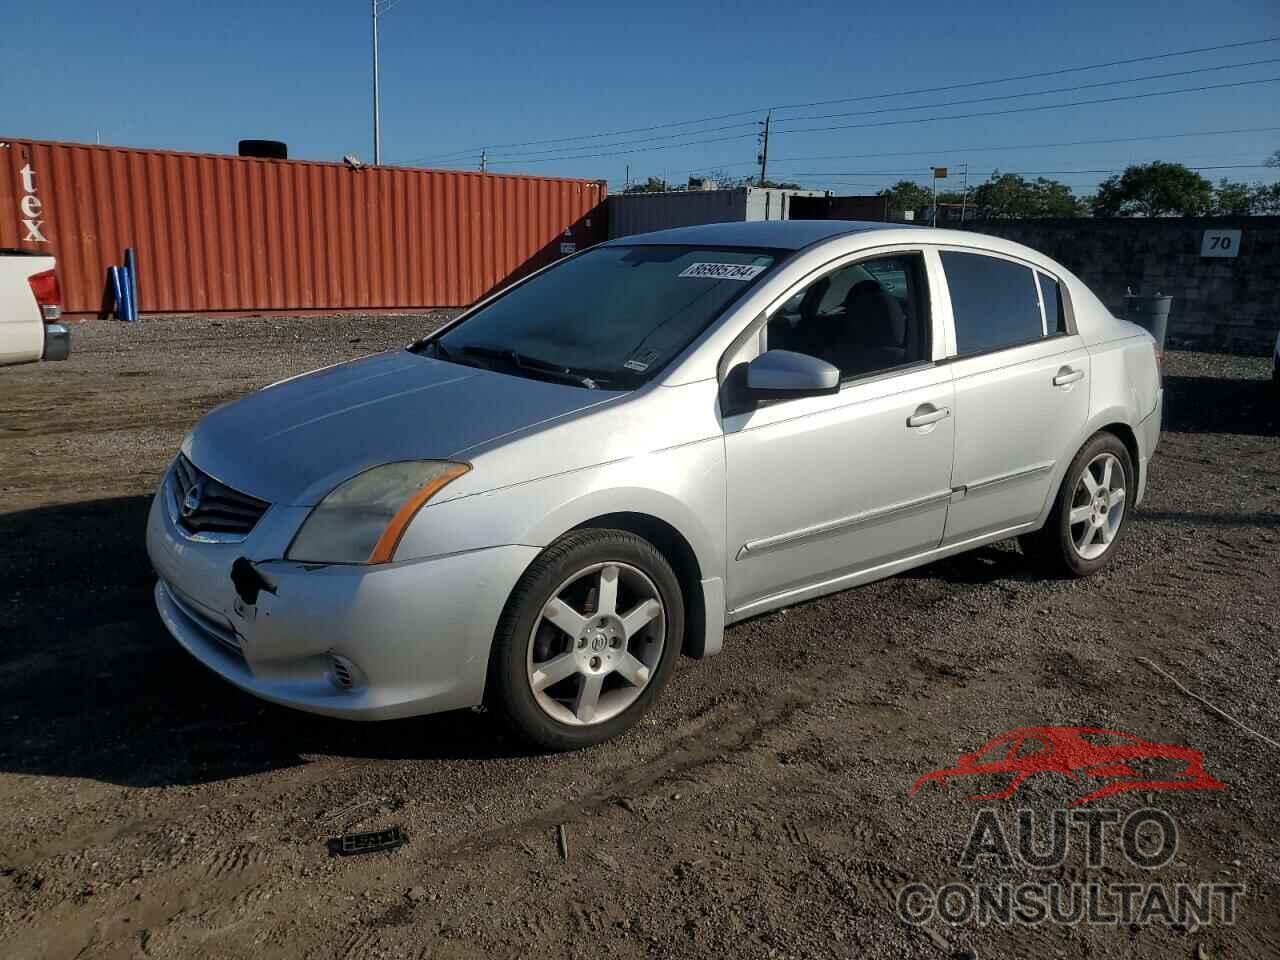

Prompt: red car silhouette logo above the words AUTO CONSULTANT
xmin=911 ymin=727 xmax=1226 ymax=806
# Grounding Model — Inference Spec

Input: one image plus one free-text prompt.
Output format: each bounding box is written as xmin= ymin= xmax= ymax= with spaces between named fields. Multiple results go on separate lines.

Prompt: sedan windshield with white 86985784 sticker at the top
xmin=419 ymin=244 xmax=780 ymax=389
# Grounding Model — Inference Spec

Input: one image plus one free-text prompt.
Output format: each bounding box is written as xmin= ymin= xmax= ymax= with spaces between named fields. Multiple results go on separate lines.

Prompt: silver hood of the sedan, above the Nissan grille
xmin=183 ymin=351 xmax=620 ymax=506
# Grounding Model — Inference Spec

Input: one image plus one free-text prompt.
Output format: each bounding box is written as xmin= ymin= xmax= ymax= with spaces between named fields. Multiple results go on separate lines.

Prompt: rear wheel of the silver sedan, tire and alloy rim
xmin=1018 ymin=433 xmax=1135 ymax=577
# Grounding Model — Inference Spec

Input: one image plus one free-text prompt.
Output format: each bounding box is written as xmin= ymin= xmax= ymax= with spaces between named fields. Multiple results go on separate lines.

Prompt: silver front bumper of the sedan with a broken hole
xmin=147 ymin=488 xmax=538 ymax=719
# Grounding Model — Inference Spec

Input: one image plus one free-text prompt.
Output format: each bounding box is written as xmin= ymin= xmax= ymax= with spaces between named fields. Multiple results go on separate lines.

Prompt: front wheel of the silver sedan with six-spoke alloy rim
xmin=486 ymin=530 xmax=685 ymax=750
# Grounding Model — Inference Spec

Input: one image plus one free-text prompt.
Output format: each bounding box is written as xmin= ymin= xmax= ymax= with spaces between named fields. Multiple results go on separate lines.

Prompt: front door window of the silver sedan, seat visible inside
xmin=765 ymin=253 xmax=929 ymax=379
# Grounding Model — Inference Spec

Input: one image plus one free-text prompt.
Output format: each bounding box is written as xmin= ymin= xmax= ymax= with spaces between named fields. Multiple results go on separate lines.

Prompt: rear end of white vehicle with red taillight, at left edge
xmin=0 ymin=248 xmax=72 ymax=366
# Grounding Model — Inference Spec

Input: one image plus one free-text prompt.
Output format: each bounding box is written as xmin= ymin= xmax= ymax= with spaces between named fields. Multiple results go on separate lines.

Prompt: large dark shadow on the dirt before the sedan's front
xmin=0 ymin=497 xmax=527 ymax=786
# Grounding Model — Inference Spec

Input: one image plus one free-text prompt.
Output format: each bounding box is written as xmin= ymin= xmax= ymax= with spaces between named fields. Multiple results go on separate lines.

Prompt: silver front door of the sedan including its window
xmin=723 ymin=251 xmax=954 ymax=614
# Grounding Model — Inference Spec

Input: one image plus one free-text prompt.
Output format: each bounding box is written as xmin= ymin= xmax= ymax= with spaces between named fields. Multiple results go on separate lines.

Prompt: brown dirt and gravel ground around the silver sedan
xmin=0 ymin=316 xmax=1280 ymax=960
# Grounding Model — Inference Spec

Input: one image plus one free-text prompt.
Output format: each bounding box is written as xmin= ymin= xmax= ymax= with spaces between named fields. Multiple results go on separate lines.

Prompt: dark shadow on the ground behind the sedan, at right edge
xmin=1162 ymin=376 xmax=1280 ymax=436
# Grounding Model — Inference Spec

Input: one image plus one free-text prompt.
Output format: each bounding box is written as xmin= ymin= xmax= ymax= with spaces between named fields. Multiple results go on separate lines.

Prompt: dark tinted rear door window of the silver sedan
xmin=942 ymin=251 xmax=1044 ymax=356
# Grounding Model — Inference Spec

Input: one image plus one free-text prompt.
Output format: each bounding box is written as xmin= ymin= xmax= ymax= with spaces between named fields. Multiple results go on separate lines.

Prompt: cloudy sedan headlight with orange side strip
xmin=287 ymin=460 xmax=471 ymax=563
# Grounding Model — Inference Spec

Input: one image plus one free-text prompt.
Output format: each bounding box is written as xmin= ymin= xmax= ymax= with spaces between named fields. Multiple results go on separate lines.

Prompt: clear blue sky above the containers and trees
xmin=0 ymin=0 xmax=1280 ymax=193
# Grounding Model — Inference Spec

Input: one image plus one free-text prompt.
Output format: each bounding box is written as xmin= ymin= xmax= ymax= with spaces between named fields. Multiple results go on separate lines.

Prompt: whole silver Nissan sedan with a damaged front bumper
xmin=147 ymin=221 xmax=1162 ymax=750
